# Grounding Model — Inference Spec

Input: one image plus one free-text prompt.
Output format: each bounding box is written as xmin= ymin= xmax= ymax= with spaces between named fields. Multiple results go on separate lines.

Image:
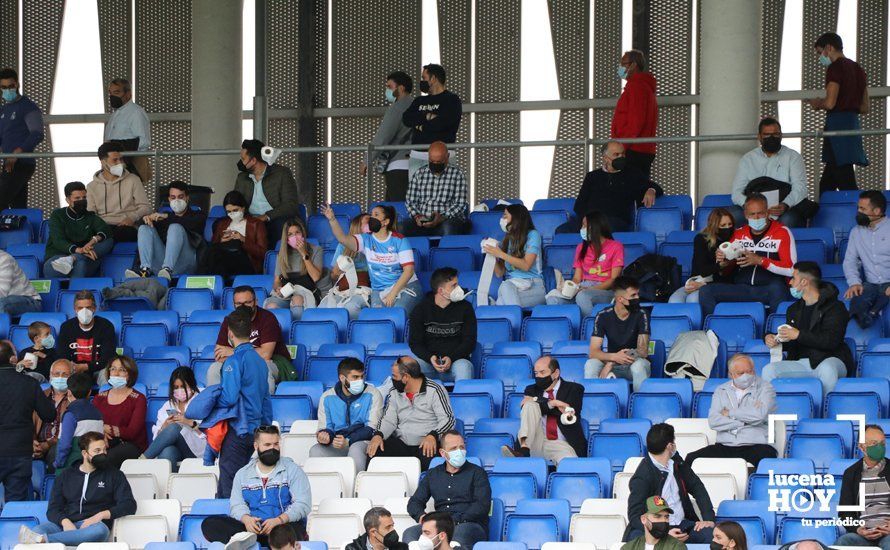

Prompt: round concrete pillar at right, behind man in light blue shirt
xmin=697 ymin=0 xmax=761 ymax=201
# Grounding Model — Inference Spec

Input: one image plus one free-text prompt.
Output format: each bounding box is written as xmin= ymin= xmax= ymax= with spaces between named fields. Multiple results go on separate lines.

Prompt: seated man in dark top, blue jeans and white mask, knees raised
xmin=126 ymin=181 xmax=207 ymax=281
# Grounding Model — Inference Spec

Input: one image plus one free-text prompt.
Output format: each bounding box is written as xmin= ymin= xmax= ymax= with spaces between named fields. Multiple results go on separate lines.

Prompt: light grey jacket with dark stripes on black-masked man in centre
xmin=377 ymin=376 xmax=454 ymax=446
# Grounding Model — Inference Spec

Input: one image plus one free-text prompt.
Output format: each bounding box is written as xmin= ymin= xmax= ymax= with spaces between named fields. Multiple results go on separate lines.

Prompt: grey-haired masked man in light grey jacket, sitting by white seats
xmin=686 ymin=353 xmax=776 ymax=469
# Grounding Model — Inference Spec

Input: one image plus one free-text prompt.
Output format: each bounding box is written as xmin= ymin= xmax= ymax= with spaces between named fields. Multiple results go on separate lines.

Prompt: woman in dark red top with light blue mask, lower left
xmin=93 ymin=355 xmax=147 ymax=468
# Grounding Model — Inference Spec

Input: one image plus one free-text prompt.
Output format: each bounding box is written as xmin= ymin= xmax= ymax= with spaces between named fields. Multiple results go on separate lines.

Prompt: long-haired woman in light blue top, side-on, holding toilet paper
xmin=483 ymin=204 xmax=546 ymax=307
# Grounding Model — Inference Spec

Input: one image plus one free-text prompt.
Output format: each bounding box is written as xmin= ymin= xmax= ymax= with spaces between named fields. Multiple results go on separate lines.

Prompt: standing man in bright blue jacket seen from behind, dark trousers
xmin=214 ymin=305 xmax=277 ymax=502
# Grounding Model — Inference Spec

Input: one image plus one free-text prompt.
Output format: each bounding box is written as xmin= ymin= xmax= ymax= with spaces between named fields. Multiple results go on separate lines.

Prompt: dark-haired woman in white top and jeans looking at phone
xmin=145 ymin=367 xmax=207 ymax=472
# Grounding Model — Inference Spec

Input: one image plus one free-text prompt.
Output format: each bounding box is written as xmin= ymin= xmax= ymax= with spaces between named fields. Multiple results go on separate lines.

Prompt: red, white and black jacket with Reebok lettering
xmin=724 ymin=220 xmax=797 ymax=286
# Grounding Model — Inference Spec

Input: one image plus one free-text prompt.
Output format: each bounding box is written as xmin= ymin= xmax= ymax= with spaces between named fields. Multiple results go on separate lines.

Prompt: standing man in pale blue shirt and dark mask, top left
xmin=105 ymin=78 xmax=152 ymax=182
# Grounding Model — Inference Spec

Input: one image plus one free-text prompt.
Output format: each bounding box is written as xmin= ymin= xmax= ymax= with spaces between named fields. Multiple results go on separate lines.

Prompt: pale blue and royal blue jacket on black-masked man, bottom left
xmin=229 ymin=456 xmax=312 ymax=523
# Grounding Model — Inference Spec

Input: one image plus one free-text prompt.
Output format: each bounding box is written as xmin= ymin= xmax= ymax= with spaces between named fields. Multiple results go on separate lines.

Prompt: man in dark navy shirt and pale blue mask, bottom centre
xmin=402 ymin=430 xmax=491 ymax=548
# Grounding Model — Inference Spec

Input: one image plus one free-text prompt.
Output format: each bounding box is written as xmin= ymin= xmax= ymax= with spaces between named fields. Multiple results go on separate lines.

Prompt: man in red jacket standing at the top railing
xmin=612 ymin=50 xmax=658 ymax=178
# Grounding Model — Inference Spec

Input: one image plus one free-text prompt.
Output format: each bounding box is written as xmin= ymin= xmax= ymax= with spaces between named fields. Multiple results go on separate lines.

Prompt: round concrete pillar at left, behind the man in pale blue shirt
xmin=191 ymin=0 xmax=242 ymax=204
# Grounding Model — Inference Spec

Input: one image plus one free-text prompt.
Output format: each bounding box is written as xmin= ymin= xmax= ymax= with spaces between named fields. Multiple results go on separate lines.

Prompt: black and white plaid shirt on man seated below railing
xmin=405 ymin=164 xmax=469 ymax=220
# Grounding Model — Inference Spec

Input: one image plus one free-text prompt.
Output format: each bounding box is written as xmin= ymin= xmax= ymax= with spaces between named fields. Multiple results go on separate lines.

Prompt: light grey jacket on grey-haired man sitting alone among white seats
xmin=708 ymin=377 xmax=776 ymax=447
